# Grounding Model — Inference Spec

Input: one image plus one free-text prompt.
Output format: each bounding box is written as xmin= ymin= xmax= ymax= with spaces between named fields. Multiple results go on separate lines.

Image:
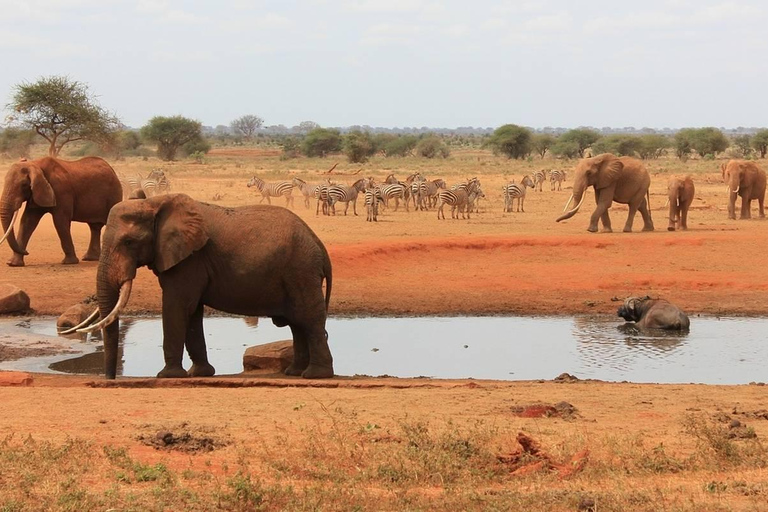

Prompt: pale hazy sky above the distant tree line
xmin=0 ymin=0 xmax=768 ymax=128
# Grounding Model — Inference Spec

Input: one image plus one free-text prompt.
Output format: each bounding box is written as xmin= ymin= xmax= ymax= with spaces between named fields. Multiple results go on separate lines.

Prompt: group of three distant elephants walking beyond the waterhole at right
xmin=557 ymin=153 xmax=766 ymax=233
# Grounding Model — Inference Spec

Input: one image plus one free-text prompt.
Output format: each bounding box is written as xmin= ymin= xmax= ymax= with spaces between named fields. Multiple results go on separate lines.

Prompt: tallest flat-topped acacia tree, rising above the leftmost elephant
xmin=6 ymin=76 xmax=121 ymax=156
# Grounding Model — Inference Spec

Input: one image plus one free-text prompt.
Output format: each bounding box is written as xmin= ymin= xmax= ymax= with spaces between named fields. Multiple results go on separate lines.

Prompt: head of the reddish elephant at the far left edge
xmin=0 ymin=159 xmax=56 ymax=255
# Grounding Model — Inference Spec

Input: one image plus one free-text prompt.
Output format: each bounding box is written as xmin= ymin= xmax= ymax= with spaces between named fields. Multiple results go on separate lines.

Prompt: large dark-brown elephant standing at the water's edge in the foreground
xmin=78 ymin=194 xmax=333 ymax=379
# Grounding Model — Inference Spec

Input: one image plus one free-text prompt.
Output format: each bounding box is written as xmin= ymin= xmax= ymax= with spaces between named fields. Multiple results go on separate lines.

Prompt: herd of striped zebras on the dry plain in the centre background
xmin=247 ymin=169 xmax=566 ymax=222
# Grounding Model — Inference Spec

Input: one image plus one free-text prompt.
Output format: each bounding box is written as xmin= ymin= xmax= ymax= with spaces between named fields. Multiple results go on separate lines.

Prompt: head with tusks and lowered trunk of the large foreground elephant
xmin=86 ymin=194 xmax=208 ymax=379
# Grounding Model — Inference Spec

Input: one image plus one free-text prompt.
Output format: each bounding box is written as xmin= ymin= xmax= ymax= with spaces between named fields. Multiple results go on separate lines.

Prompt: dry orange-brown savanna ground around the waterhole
xmin=0 ymin=148 xmax=768 ymax=511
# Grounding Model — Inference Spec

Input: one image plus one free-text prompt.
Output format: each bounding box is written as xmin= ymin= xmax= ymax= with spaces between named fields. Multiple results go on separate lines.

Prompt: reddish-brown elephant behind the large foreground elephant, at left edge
xmin=0 ymin=157 xmax=123 ymax=267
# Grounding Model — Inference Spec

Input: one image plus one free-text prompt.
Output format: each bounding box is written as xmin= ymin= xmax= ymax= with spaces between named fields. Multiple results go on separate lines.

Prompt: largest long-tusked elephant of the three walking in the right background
xmin=557 ymin=153 xmax=653 ymax=233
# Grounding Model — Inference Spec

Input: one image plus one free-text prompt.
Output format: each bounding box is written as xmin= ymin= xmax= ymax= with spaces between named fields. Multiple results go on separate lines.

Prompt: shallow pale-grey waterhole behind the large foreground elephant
xmin=0 ymin=317 xmax=768 ymax=384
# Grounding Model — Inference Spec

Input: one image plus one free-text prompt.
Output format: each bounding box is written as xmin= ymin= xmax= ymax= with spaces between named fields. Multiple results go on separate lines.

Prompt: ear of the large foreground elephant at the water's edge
xmin=152 ymin=194 xmax=208 ymax=273
